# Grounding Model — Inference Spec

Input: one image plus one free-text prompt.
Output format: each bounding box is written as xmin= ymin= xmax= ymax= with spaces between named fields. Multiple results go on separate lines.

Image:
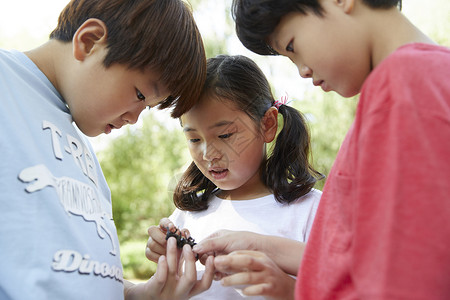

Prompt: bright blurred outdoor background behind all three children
xmin=0 ymin=0 xmax=450 ymax=279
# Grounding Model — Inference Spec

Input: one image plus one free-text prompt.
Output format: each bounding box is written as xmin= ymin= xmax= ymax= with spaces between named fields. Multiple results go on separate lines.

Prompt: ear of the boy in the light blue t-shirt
xmin=72 ymin=19 xmax=107 ymax=61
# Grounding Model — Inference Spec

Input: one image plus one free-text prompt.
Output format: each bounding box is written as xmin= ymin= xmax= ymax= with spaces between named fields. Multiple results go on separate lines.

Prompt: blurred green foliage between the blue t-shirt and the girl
xmin=98 ymin=111 xmax=189 ymax=243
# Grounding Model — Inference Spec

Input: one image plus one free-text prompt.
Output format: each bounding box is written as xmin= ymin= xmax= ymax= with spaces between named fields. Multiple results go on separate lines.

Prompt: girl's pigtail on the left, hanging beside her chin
xmin=173 ymin=162 xmax=217 ymax=211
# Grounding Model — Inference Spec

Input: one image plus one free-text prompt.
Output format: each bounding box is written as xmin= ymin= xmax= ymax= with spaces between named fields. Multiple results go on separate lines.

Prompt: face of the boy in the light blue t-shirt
xmin=67 ymin=48 xmax=170 ymax=136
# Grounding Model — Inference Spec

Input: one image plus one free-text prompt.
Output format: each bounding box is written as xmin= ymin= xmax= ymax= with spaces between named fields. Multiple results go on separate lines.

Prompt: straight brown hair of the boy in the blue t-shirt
xmin=50 ymin=0 xmax=206 ymax=118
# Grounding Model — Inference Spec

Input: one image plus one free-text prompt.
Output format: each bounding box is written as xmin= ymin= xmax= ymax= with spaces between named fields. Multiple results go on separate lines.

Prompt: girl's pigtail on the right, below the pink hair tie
xmin=263 ymin=105 xmax=324 ymax=203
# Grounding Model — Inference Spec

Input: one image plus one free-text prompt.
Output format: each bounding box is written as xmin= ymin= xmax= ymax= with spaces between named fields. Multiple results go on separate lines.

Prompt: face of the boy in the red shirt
xmin=269 ymin=0 xmax=371 ymax=97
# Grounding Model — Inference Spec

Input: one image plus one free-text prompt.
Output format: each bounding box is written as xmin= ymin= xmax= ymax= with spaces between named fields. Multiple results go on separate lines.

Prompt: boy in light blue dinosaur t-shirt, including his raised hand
xmin=0 ymin=0 xmax=212 ymax=299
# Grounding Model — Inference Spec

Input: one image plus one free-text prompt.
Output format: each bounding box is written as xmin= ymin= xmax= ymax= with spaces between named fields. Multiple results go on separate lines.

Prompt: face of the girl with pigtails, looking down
xmin=181 ymin=95 xmax=268 ymax=200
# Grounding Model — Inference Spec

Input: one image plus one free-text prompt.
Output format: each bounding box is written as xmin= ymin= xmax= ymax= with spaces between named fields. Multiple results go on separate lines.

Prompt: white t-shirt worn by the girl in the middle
xmin=169 ymin=189 xmax=322 ymax=300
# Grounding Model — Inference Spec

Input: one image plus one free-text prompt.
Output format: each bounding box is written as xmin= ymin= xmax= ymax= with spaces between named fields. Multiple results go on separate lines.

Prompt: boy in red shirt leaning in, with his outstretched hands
xmin=195 ymin=0 xmax=450 ymax=300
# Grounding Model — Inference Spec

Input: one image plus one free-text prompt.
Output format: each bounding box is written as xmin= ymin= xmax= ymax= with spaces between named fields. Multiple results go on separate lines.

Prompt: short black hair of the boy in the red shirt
xmin=231 ymin=0 xmax=402 ymax=55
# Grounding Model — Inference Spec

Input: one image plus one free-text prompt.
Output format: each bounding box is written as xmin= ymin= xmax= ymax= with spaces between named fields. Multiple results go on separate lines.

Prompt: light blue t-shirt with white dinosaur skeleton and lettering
xmin=0 ymin=50 xmax=123 ymax=300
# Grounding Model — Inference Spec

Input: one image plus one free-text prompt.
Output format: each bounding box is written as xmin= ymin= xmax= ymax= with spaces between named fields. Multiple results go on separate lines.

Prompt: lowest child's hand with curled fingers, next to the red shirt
xmin=214 ymin=250 xmax=295 ymax=299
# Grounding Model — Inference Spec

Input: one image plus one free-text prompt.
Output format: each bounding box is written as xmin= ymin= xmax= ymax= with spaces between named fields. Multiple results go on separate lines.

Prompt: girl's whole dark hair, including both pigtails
xmin=173 ymin=55 xmax=324 ymax=211
